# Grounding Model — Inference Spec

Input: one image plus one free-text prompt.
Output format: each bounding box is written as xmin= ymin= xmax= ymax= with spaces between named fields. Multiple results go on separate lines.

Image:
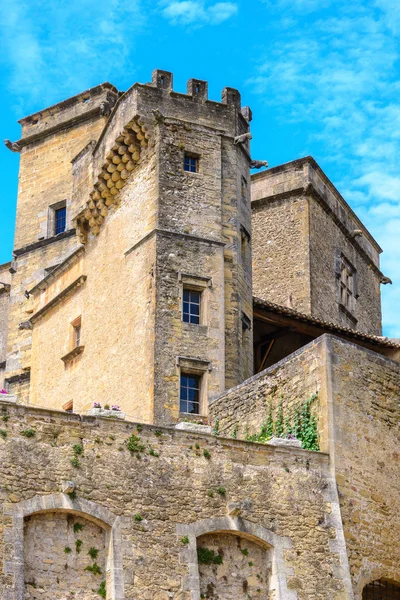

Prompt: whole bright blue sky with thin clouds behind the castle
xmin=0 ymin=0 xmax=400 ymax=337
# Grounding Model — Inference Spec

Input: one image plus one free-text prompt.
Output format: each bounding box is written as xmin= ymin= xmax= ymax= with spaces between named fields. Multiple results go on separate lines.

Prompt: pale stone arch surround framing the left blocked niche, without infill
xmin=4 ymin=494 xmax=124 ymax=600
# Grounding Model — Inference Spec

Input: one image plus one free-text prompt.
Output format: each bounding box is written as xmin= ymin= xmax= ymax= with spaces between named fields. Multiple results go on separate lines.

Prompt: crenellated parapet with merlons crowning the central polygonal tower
xmin=71 ymin=70 xmax=251 ymax=231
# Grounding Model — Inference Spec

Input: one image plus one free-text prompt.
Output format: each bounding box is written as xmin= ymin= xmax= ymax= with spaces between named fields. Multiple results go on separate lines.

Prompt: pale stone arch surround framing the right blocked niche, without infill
xmin=177 ymin=516 xmax=297 ymax=600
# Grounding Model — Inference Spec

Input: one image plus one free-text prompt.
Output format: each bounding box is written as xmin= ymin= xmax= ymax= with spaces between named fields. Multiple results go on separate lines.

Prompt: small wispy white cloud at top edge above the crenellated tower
xmin=162 ymin=0 xmax=238 ymax=26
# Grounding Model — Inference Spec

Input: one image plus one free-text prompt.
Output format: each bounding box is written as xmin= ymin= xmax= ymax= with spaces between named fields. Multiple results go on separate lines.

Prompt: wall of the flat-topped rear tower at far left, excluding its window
xmin=6 ymin=86 xmax=110 ymax=398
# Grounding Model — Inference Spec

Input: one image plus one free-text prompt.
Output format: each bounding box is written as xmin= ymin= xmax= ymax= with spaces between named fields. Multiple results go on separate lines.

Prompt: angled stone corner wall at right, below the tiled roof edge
xmin=210 ymin=335 xmax=400 ymax=600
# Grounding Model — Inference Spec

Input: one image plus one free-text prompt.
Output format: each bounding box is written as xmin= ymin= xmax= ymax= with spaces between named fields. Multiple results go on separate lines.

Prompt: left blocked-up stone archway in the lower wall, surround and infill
xmin=4 ymin=494 xmax=124 ymax=600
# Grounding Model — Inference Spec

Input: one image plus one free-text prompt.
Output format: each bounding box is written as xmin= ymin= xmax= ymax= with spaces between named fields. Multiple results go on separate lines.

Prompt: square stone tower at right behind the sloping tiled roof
xmin=252 ymin=157 xmax=384 ymax=335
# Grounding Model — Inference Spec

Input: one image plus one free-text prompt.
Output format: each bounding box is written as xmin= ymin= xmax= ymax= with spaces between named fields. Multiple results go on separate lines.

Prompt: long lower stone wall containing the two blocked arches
xmin=0 ymin=403 xmax=351 ymax=600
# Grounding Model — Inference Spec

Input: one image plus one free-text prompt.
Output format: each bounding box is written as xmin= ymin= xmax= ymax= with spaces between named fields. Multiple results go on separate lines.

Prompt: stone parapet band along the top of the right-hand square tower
xmin=251 ymin=156 xmax=382 ymax=269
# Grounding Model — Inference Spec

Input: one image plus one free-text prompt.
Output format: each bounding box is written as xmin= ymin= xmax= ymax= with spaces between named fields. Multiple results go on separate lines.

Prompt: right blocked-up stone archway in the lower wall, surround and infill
xmin=177 ymin=516 xmax=297 ymax=600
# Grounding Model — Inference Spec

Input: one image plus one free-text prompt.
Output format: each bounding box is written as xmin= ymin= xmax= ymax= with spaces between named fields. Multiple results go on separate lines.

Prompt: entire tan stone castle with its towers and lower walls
xmin=0 ymin=70 xmax=400 ymax=600
